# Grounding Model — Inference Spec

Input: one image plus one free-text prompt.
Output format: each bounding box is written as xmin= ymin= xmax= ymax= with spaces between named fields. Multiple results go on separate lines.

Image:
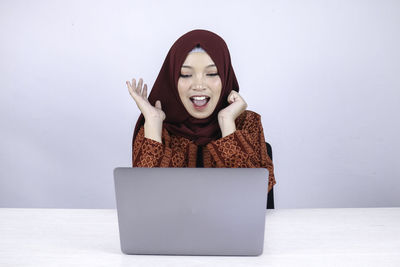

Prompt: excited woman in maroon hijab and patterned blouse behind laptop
xmin=126 ymin=30 xmax=276 ymax=195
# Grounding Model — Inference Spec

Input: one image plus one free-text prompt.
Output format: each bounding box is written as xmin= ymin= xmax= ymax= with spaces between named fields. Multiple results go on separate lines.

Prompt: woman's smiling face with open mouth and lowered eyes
xmin=178 ymin=52 xmax=222 ymax=119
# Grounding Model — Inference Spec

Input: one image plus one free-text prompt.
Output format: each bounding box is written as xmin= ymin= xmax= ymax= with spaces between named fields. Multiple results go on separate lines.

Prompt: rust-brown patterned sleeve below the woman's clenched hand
xmin=207 ymin=111 xmax=276 ymax=191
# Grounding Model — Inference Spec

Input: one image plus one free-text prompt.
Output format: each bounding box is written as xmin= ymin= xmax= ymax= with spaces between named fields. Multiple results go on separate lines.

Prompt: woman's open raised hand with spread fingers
xmin=126 ymin=78 xmax=165 ymax=125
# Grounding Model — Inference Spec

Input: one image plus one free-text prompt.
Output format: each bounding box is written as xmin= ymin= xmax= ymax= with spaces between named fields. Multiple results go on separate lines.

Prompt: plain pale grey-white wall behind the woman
xmin=0 ymin=0 xmax=400 ymax=208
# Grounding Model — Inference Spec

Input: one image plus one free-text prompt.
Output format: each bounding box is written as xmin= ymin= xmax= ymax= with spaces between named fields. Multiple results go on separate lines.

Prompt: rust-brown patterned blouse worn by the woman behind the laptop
xmin=132 ymin=110 xmax=276 ymax=191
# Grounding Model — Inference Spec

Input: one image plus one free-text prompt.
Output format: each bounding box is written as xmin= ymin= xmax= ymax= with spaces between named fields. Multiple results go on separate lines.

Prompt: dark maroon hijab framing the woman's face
xmin=133 ymin=30 xmax=239 ymax=145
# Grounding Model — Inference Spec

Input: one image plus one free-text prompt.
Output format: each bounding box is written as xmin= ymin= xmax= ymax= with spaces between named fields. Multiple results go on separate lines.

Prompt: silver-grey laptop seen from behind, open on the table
xmin=114 ymin=168 xmax=268 ymax=256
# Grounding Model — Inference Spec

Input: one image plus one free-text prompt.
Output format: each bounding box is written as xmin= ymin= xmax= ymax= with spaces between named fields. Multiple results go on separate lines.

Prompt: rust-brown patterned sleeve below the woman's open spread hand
xmin=132 ymin=126 xmax=185 ymax=168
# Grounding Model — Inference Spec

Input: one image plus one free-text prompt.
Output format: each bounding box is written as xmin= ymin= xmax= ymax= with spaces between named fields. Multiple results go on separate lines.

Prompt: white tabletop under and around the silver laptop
xmin=0 ymin=208 xmax=400 ymax=267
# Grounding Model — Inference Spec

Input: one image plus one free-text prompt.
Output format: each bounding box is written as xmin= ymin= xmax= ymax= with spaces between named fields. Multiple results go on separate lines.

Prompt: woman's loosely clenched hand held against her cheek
xmin=218 ymin=90 xmax=247 ymax=137
